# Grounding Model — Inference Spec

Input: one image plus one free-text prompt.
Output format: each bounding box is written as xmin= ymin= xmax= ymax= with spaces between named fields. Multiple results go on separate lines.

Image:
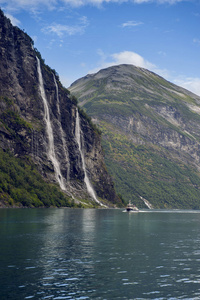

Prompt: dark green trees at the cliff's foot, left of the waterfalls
xmin=0 ymin=149 xmax=75 ymax=207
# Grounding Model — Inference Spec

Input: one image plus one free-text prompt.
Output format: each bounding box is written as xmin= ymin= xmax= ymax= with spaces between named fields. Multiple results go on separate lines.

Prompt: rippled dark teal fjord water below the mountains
xmin=0 ymin=208 xmax=200 ymax=300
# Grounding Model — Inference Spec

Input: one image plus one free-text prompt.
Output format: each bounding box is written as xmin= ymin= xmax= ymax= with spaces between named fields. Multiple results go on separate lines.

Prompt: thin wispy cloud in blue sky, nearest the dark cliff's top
xmin=42 ymin=16 xmax=89 ymax=38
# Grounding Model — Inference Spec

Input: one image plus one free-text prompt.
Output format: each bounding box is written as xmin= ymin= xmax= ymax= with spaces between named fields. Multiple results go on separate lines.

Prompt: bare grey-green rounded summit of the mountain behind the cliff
xmin=69 ymin=64 xmax=200 ymax=105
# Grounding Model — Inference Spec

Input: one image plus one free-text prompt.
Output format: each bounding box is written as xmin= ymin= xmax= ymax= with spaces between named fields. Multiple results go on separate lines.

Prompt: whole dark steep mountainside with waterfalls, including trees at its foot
xmin=0 ymin=11 xmax=121 ymax=207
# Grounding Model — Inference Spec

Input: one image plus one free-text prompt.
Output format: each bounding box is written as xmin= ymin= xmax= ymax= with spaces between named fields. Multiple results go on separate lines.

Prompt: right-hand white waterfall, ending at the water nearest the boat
xmin=75 ymin=109 xmax=104 ymax=206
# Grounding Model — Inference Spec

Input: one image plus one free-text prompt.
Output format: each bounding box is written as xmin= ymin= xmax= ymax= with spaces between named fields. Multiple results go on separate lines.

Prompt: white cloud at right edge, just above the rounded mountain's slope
xmin=173 ymin=77 xmax=200 ymax=96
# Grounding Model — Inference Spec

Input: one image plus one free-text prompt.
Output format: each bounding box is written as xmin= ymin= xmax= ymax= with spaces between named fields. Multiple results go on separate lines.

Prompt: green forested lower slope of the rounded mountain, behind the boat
xmin=101 ymin=123 xmax=200 ymax=209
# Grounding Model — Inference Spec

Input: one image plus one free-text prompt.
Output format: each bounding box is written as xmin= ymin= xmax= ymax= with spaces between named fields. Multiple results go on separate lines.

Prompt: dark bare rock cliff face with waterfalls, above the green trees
xmin=0 ymin=11 xmax=119 ymax=204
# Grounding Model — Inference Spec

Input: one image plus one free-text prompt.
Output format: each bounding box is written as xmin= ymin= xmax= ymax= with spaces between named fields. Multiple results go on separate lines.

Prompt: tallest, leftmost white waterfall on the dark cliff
xmin=36 ymin=57 xmax=65 ymax=190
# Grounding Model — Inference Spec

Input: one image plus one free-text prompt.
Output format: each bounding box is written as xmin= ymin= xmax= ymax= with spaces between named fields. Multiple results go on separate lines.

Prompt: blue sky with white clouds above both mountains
xmin=0 ymin=0 xmax=200 ymax=95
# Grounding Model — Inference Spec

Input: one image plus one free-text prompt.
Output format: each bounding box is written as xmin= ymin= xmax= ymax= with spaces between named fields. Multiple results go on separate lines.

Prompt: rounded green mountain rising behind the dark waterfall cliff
xmin=69 ymin=65 xmax=200 ymax=209
